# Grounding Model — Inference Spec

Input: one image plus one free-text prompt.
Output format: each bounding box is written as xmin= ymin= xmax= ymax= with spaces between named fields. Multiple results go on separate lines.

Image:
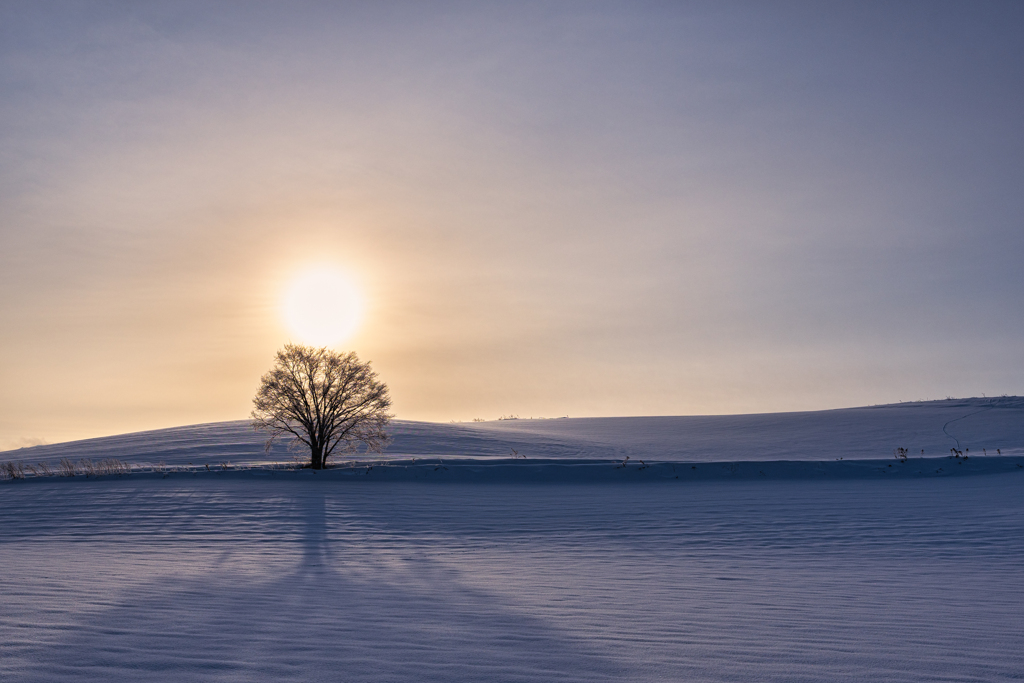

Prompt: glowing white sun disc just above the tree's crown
xmin=283 ymin=266 xmax=362 ymax=346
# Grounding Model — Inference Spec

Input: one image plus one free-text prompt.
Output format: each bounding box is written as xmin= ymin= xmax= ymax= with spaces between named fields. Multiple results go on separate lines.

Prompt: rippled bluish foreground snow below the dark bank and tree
xmin=0 ymin=474 xmax=1024 ymax=682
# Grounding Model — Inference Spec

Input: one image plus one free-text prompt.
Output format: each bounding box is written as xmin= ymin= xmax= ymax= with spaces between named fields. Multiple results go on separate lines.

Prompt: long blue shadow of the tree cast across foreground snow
xmin=18 ymin=487 xmax=626 ymax=682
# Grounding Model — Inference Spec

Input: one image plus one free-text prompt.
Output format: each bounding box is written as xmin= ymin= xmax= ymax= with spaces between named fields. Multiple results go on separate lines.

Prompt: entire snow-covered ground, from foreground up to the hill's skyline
xmin=0 ymin=398 xmax=1024 ymax=681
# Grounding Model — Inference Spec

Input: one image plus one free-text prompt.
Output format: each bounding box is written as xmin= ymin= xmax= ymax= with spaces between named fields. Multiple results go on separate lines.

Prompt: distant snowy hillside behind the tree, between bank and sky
xmin=0 ymin=396 xmax=1024 ymax=465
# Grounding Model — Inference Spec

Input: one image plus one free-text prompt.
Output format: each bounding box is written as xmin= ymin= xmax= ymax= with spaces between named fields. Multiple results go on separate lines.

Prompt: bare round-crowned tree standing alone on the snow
xmin=252 ymin=344 xmax=393 ymax=470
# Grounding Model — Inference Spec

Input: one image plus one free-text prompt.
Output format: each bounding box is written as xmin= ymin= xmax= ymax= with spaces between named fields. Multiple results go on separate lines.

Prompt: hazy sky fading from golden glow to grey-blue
xmin=0 ymin=1 xmax=1024 ymax=447
